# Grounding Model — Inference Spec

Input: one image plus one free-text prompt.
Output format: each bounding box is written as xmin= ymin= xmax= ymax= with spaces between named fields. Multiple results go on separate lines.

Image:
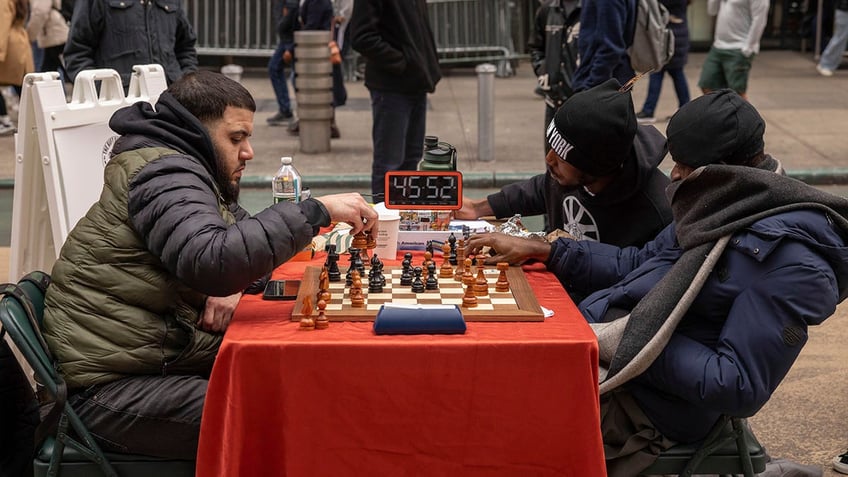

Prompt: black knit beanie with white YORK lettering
xmin=546 ymin=79 xmax=636 ymax=177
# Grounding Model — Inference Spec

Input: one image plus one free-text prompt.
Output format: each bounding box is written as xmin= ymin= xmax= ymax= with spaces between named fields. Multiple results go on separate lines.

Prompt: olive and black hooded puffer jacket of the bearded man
xmin=44 ymin=92 xmax=329 ymax=389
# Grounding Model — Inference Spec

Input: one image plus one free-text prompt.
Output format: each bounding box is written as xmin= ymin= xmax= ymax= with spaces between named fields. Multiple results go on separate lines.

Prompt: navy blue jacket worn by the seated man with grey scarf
xmin=547 ymin=210 xmax=848 ymax=442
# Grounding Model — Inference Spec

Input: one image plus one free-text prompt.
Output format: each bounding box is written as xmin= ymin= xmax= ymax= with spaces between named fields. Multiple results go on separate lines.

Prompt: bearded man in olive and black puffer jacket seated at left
xmin=44 ymin=71 xmax=377 ymax=459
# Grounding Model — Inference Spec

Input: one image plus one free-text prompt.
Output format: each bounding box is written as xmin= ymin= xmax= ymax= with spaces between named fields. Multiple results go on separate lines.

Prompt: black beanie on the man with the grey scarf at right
xmin=666 ymin=89 xmax=766 ymax=168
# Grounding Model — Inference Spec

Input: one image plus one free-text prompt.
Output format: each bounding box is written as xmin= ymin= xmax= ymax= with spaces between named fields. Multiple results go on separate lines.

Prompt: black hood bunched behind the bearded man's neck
xmin=109 ymin=91 xmax=217 ymax=177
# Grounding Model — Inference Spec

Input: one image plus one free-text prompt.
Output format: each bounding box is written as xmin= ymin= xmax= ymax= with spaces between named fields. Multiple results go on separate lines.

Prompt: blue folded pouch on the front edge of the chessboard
xmin=374 ymin=304 xmax=465 ymax=335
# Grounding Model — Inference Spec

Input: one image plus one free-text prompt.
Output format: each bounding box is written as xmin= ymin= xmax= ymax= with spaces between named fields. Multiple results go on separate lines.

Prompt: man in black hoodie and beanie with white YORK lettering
xmin=456 ymin=79 xmax=671 ymax=280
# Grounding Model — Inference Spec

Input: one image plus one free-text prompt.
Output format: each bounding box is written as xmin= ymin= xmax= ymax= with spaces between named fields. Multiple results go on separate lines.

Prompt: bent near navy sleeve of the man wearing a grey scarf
xmin=636 ymin=241 xmax=839 ymax=417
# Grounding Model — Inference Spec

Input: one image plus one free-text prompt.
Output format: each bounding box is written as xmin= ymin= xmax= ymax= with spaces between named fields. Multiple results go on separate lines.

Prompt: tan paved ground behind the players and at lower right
xmin=0 ymin=51 xmax=848 ymax=476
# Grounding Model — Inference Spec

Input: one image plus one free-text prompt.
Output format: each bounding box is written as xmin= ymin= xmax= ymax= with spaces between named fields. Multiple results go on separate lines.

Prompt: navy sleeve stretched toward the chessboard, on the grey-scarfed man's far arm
xmin=546 ymin=224 xmax=676 ymax=296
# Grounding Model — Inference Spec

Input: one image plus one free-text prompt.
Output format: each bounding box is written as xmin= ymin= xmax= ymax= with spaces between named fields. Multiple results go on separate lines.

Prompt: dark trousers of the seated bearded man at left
xmin=68 ymin=376 xmax=209 ymax=460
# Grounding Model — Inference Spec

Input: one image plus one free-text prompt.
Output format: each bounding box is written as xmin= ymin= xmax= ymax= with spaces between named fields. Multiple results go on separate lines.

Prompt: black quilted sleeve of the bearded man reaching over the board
xmin=128 ymin=155 xmax=322 ymax=296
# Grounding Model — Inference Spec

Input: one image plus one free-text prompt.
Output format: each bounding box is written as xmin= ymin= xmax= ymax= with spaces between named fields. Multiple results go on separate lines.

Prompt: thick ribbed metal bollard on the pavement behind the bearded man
xmin=294 ymin=30 xmax=333 ymax=153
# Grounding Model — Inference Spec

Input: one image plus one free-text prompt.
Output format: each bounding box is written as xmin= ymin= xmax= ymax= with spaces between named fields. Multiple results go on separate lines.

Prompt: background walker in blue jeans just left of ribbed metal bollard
xmin=268 ymin=0 xmax=298 ymax=126
